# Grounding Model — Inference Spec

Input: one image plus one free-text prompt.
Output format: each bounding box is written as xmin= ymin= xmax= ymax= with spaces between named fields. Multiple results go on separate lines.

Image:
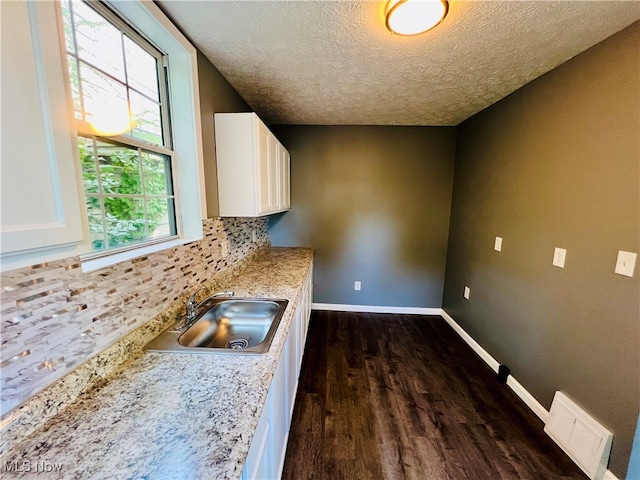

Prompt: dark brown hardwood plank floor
xmin=282 ymin=312 xmax=587 ymax=480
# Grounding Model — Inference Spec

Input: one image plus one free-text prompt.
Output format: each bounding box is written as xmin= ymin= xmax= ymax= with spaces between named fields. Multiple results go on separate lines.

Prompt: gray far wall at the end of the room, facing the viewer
xmin=270 ymin=126 xmax=455 ymax=307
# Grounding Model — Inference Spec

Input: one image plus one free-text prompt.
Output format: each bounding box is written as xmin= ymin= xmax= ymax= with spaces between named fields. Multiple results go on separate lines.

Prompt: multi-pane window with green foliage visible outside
xmin=62 ymin=0 xmax=181 ymax=253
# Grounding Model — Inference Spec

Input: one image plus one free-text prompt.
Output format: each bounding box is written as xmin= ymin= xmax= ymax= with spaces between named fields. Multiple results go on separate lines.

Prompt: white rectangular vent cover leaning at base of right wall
xmin=544 ymin=392 xmax=613 ymax=480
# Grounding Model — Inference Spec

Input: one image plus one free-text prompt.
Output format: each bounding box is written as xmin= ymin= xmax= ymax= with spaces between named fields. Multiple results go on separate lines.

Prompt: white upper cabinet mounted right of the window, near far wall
xmin=215 ymin=113 xmax=291 ymax=217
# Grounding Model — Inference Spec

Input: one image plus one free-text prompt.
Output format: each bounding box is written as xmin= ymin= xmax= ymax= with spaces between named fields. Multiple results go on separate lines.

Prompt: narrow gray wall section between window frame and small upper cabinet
xmin=198 ymin=52 xmax=251 ymax=218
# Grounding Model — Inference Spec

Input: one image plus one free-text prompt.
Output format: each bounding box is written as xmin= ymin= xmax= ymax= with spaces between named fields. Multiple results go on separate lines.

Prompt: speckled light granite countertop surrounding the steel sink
xmin=1 ymin=248 xmax=313 ymax=480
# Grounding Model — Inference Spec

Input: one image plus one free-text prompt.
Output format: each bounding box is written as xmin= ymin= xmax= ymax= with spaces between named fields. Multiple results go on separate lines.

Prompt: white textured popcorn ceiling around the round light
xmin=158 ymin=0 xmax=640 ymax=125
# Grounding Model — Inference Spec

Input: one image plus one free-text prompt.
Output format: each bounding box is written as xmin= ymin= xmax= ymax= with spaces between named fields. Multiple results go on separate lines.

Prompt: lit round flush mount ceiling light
xmin=385 ymin=0 xmax=449 ymax=36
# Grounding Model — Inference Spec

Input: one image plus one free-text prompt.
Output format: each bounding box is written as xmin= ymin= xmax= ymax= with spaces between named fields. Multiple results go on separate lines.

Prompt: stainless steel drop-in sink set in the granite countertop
xmin=145 ymin=297 xmax=289 ymax=354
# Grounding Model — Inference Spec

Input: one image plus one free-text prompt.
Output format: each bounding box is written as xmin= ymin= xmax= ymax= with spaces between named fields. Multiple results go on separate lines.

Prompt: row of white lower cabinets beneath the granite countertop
xmin=242 ymin=269 xmax=312 ymax=480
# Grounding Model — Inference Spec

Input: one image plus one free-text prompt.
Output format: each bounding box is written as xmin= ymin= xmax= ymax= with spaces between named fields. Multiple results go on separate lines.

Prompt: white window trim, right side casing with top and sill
xmin=76 ymin=0 xmax=206 ymax=272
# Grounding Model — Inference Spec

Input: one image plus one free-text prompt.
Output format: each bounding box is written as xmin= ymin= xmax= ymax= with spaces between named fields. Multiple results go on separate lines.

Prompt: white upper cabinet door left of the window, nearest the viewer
xmin=0 ymin=2 xmax=88 ymax=270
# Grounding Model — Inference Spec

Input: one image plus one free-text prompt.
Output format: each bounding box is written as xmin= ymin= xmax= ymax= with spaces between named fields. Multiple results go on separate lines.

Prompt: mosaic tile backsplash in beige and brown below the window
xmin=0 ymin=217 xmax=269 ymax=416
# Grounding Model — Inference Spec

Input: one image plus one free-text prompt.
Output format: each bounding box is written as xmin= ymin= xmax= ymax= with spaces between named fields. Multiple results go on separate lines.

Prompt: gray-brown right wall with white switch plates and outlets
xmin=444 ymin=23 xmax=640 ymax=478
